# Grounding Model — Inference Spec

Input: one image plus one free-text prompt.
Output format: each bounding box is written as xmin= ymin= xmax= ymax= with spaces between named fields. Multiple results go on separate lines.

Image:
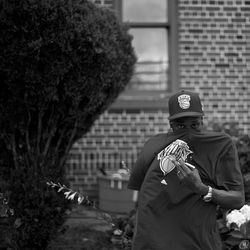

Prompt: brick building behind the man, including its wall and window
xmin=67 ymin=0 xmax=250 ymax=195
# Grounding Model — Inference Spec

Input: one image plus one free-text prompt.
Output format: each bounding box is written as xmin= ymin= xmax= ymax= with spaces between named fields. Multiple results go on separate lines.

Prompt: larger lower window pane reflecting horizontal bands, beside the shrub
xmin=129 ymin=28 xmax=168 ymax=90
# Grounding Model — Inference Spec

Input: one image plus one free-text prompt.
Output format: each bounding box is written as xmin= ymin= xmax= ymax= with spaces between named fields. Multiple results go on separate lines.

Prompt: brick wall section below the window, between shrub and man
xmin=67 ymin=110 xmax=168 ymax=196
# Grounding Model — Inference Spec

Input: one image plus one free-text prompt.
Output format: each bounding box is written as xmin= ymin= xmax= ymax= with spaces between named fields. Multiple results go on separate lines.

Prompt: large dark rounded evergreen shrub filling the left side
xmin=0 ymin=0 xmax=136 ymax=250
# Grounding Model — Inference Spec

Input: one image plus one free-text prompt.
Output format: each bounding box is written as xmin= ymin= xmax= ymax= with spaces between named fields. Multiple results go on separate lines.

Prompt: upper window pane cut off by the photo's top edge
xmin=122 ymin=0 xmax=167 ymax=22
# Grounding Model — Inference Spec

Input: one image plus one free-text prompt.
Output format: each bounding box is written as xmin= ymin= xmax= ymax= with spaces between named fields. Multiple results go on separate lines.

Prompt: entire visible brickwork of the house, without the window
xmin=67 ymin=0 xmax=250 ymax=196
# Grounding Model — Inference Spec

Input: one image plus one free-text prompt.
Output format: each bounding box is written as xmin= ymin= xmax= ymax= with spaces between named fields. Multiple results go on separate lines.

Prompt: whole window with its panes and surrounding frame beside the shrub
xmin=114 ymin=0 xmax=177 ymax=99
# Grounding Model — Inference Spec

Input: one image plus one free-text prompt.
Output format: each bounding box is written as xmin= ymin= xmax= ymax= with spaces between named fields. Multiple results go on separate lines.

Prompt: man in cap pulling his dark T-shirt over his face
xmin=128 ymin=91 xmax=245 ymax=250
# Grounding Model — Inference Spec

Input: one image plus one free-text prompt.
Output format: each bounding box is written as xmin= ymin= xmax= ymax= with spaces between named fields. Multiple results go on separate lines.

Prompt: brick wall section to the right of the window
xmin=178 ymin=0 xmax=250 ymax=133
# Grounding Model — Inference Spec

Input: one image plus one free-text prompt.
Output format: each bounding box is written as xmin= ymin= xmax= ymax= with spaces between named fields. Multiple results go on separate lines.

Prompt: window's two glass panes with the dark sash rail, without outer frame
xmin=121 ymin=0 xmax=169 ymax=90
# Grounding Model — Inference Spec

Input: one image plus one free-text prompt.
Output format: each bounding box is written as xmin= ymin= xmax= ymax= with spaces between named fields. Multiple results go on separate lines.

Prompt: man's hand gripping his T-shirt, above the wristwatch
xmin=173 ymin=159 xmax=208 ymax=195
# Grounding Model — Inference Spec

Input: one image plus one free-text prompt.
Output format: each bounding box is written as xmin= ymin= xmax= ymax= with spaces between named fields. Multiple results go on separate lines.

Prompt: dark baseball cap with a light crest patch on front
xmin=168 ymin=90 xmax=204 ymax=120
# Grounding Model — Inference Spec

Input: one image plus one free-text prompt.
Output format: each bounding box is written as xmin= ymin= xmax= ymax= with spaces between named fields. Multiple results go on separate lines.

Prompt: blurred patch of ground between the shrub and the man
xmin=48 ymin=206 xmax=132 ymax=250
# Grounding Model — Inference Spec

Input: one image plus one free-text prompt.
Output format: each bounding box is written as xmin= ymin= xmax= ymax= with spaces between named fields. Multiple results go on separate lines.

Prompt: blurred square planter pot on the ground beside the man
xmin=98 ymin=175 xmax=137 ymax=213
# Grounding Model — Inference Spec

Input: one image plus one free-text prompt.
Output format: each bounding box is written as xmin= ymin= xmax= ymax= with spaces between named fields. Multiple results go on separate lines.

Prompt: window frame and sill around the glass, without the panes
xmin=111 ymin=0 xmax=179 ymax=109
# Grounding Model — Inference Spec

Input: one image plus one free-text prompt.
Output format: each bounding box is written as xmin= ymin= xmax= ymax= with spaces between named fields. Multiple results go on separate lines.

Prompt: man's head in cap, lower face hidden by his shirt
xmin=168 ymin=90 xmax=204 ymax=131
